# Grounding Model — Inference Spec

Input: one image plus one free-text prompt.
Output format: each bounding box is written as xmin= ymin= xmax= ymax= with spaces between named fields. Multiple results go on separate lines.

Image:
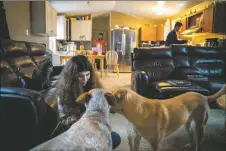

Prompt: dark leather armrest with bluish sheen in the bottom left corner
xmin=0 ymin=87 xmax=57 ymax=151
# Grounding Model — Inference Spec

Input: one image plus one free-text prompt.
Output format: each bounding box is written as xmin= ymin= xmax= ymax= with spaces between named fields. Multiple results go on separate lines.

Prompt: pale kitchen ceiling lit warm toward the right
xmin=49 ymin=0 xmax=201 ymax=20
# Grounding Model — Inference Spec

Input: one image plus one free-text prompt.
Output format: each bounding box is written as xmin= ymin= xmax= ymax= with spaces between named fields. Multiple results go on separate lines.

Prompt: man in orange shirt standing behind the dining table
xmin=94 ymin=33 xmax=107 ymax=68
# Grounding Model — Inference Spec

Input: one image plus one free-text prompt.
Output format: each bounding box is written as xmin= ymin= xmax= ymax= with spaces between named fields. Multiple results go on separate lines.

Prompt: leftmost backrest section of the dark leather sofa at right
xmin=133 ymin=47 xmax=174 ymax=81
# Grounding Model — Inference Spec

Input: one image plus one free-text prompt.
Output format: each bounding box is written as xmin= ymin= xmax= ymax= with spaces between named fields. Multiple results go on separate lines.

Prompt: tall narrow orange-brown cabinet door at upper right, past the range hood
xmin=203 ymin=7 xmax=214 ymax=32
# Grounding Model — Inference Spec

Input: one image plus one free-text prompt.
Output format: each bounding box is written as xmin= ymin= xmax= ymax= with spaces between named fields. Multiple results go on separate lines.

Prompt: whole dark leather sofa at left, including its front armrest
xmin=0 ymin=39 xmax=63 ymax=151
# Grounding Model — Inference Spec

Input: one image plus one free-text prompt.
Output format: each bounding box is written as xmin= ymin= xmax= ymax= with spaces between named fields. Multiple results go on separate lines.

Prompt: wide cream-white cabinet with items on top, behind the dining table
xmin=71 ymin=18 xmax=92 ymax=41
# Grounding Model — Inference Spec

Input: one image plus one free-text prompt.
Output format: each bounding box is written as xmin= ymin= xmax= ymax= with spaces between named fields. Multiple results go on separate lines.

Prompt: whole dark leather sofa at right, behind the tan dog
xmin=131 ymin=45 xmax=226 ymax=99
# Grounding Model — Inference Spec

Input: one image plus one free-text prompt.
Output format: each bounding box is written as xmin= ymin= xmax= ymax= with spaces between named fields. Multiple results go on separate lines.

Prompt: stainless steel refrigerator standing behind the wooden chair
xmin=111 ymin=29 xmax=136 ymax=72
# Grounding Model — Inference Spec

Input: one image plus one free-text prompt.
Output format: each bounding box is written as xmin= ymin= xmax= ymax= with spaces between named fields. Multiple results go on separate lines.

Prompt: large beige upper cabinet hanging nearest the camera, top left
xmin=30 ymin=1 xmax=57 ymax=36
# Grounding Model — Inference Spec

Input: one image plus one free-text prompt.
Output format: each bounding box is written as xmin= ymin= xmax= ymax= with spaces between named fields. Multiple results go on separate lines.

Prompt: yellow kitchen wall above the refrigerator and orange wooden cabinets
xmin=110 ymin=12 xmax=164 ymax=46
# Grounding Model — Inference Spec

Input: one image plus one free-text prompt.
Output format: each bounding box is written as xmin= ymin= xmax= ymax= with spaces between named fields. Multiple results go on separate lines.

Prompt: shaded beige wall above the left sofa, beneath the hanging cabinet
xmin=3 ymin=1 xmax=49 ymax=48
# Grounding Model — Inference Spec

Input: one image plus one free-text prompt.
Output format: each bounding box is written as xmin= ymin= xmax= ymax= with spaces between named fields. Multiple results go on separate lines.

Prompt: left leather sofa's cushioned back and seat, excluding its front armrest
xmin=0 ymin=40 xmax=62 ymax=91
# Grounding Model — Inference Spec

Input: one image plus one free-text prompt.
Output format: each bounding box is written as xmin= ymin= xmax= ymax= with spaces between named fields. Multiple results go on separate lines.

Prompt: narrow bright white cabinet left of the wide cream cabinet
xmin=56 ymin=15 xmax=67 ymax=40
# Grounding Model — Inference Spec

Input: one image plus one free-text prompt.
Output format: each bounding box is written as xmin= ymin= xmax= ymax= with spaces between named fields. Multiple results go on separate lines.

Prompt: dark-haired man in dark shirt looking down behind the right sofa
xmin=165 ymin=22 xmax=187 ymax=46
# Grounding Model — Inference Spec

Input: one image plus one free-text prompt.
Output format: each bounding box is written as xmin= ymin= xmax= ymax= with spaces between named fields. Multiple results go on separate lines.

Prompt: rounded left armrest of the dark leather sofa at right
xmin=131 ymin=71 xmax=149 ymax=96
